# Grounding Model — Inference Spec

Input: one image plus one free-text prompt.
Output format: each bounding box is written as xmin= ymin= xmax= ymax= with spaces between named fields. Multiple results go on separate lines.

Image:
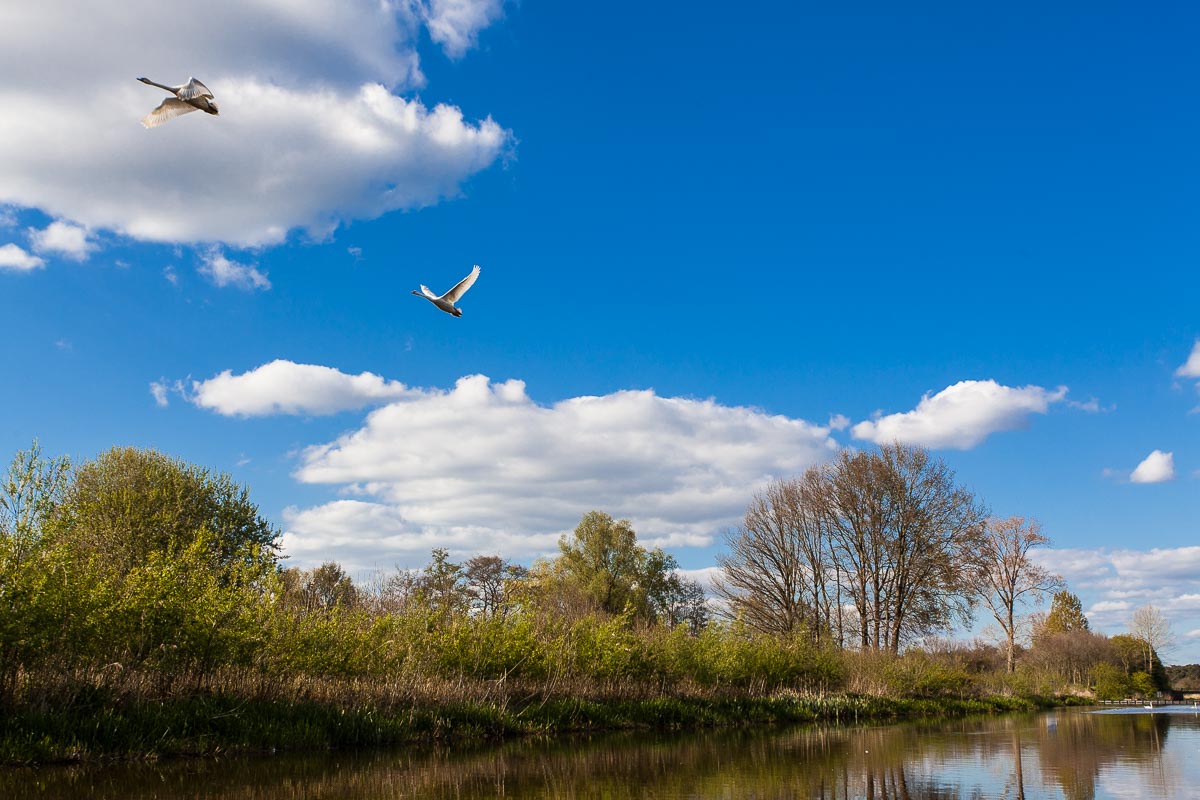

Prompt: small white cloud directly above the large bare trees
xmin=851 ymin=380 xmax=1067 ymax=450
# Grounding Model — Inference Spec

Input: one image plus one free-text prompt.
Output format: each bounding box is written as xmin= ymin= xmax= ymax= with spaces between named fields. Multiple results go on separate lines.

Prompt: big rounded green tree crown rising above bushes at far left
xmin=54 ymin=447 xmax=278 ymax=573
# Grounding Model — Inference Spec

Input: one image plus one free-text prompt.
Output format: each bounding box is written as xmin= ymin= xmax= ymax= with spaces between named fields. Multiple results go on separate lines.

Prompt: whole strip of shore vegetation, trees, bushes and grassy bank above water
xmin=0 ymin=443 xmax=1168 ymax=764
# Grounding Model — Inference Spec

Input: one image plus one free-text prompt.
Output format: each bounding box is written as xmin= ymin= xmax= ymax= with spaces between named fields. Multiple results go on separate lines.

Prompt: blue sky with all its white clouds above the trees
xmin=0 ymin=0 xmax=1200 ymax=662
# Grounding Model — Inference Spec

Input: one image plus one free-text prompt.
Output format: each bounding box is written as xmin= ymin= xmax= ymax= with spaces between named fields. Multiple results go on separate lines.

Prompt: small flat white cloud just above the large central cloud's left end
xmin=190 ymin=359 xmax=418 ymax=416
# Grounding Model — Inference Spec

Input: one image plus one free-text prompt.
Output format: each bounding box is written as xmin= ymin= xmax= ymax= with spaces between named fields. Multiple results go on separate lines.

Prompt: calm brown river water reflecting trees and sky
xmin=0 ymin=708 xmax=1200 ymax=800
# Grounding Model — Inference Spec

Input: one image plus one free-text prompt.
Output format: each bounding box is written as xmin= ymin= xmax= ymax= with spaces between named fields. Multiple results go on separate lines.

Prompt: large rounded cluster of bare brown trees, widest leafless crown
xmin=715 ymin=444 xmax=985 ymax=652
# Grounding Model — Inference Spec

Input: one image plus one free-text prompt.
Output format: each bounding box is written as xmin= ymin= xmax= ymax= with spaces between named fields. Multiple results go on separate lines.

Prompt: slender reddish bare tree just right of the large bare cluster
xmin=978 ymin=517 xmax=1063 ymax=673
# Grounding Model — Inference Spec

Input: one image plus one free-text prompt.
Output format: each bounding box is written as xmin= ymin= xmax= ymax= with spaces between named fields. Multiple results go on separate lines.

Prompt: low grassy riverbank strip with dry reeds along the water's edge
xmin=0 ymin=686 xmax=1064 ymax=764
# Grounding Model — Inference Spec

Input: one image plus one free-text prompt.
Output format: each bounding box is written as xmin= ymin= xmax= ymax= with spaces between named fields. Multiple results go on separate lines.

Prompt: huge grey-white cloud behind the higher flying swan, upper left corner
xmin=0 ymin=0 xmax=511 ymax=246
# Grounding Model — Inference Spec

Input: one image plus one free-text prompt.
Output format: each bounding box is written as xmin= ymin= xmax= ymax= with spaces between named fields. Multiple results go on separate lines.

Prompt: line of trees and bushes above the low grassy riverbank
xmin=0 ymin=443 xmax=1163 ymax=703
